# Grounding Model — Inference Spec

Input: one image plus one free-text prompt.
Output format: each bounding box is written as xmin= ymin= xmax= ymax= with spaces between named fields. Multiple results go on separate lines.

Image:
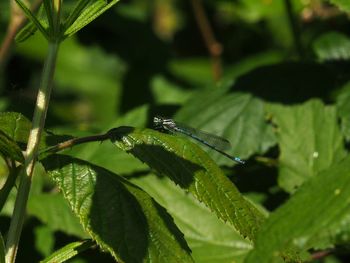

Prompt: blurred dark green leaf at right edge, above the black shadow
xmin=313 ymin=32 xmax=350 ymax=61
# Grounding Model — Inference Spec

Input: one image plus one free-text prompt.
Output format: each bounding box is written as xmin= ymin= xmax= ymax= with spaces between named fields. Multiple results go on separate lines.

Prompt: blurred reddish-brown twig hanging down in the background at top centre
xmin=191 ymin=0 xmax=222 ymax=81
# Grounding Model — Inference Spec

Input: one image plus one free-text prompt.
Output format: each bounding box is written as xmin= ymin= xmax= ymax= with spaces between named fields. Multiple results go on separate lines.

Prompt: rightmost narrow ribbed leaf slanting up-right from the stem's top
xmin=64 ymin=0 xmax=118 ymax=37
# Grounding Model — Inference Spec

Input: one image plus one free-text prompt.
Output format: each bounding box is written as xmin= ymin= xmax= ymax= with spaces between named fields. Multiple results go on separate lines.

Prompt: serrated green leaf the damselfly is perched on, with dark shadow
xmin=110 ymin=127 xmax=264 ymax=240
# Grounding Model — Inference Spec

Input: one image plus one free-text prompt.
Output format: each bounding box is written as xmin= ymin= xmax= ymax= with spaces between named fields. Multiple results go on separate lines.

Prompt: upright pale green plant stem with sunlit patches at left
xmin=6 ymin=42 xmax=59 ymax=263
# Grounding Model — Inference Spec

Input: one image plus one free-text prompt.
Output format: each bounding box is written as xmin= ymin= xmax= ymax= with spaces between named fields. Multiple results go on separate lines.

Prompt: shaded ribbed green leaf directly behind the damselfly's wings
xmin=175 ymin=85 xmax=276 ymax=165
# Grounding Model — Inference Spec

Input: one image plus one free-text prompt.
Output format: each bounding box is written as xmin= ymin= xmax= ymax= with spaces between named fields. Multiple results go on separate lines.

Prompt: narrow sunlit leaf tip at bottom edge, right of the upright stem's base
xmin=40 ymin=240 xmax=95 ymax=263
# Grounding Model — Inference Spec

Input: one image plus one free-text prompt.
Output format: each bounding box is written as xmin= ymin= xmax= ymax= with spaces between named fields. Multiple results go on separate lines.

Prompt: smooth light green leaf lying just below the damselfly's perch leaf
xmin=131 ymin=174 xmax=253 ymax=263
